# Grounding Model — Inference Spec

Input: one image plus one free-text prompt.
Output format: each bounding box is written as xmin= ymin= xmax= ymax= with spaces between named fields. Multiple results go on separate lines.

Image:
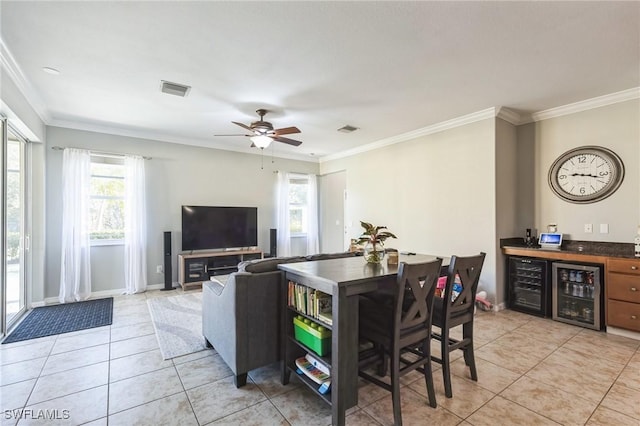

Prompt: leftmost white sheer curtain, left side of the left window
xmin=58 ymin=148 xmax=91 ymax=303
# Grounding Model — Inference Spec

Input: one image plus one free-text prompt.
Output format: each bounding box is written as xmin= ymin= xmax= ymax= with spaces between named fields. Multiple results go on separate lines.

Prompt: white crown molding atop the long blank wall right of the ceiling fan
xmin=320 ymin=108 xmax=496 ymax=163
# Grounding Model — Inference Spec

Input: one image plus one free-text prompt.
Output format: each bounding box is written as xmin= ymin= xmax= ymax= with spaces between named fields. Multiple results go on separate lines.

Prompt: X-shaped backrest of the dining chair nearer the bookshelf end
xmin=394 ymin=258 xmax=442 ymax=332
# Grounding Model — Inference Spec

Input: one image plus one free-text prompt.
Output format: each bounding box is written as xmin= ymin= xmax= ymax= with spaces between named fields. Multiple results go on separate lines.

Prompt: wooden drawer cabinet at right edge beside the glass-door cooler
xmin=606 ymin=258 xmax=640 ymax=332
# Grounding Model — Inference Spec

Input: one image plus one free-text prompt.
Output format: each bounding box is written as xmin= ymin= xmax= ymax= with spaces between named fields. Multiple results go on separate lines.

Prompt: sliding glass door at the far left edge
xmin=2 ymin=123 xmax=28 ymax=334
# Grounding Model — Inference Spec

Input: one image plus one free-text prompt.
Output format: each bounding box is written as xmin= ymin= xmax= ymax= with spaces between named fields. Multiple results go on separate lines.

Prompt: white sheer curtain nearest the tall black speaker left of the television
xmin=124 ymin=155 xmax=147 ymax=294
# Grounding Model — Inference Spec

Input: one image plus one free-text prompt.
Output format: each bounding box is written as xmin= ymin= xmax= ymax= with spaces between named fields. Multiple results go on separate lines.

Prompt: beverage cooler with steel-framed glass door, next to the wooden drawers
xmin=552 ymin=262 xmax=604 ymax=330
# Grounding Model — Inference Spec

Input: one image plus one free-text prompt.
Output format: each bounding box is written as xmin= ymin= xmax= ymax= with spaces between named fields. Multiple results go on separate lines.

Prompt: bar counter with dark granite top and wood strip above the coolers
xmin=500 ymin=238 xmax=636 ymax=263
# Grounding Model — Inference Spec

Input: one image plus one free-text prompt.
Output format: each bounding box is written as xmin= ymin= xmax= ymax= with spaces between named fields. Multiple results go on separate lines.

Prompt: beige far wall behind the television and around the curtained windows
xmin=45 ymin=127 xmax=319 ymax=297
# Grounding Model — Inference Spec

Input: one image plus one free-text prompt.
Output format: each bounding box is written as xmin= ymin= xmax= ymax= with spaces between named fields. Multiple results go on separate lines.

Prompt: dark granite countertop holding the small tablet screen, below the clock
xmin=500 ymin=238 xmax=636 ymax=259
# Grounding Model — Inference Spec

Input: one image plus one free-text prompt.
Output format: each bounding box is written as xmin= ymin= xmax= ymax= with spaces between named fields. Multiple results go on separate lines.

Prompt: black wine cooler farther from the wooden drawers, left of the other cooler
xmin=508 ymin=257 xmax=551 ymax=317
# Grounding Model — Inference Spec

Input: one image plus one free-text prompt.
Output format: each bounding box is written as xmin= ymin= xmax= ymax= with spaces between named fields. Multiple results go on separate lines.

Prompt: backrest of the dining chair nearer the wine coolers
xmin=443 ymin=253 xmax=486 ymax=316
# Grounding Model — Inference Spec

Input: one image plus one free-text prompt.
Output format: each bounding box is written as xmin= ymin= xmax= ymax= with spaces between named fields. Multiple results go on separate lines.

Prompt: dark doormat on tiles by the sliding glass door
xmin=2 ymin=297 xmax=113 ymax=345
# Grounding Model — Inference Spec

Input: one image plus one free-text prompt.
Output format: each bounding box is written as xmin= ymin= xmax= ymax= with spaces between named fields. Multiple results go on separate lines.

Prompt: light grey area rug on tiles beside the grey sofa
xmin=147 ymin=293 xmax=206 ymax=359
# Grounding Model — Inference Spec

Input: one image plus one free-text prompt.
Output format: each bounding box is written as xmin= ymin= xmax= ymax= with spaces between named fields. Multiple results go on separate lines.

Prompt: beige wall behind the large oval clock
xmin=532 ymin=100 xmax=640 ymax=243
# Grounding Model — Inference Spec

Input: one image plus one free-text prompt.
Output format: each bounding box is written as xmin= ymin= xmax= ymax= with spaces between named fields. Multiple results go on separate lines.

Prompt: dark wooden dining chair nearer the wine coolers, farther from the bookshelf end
xmin=431 ymin=253 xmax=485 ymax=398
